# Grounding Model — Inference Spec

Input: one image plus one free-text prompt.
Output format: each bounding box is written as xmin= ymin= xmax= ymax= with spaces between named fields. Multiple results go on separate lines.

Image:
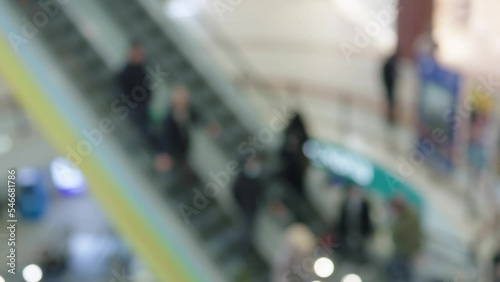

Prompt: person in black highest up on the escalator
xmin=118 ymin=43 xmax=152 ymax=141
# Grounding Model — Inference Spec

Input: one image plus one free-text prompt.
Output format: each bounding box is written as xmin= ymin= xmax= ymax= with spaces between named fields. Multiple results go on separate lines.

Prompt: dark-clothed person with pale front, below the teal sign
xmin=336 ymin=183 xmax=374 ymax=261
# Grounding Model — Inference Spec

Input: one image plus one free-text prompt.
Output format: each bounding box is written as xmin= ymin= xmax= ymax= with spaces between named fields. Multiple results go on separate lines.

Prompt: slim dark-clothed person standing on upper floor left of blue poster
xmin=382 ymin=52 xmax=398 ymax=124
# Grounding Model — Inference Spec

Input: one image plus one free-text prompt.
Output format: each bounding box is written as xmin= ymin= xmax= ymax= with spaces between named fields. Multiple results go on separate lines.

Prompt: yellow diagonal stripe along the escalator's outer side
xmin=0 ymin=37 xmax=193 ymax=282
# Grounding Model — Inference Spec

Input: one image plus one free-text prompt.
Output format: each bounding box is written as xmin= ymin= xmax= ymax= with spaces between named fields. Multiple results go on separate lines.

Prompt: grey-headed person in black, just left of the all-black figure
xmin=233 ymin=157 xmax=264 ymax=252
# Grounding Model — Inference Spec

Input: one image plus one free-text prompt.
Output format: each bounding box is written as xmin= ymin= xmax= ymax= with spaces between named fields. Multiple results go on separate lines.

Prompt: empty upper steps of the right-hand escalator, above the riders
xmin=100 ymin=0 xmax=257 ymax=158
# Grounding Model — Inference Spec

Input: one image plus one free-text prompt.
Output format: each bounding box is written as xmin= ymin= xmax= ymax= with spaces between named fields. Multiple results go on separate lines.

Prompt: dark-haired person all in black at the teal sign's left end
xmin=281 ymin=113 xmax=309 ymax=197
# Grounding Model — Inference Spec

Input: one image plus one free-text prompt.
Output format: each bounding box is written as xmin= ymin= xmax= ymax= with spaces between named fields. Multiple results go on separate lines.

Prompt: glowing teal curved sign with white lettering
xmin=303 ymin=140 xmax=423 ymax=208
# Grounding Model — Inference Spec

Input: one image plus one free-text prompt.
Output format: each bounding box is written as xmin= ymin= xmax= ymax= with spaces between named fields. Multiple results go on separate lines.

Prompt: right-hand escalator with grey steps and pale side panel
xmin=96 ymin=0 xmax=327 ymax=235
